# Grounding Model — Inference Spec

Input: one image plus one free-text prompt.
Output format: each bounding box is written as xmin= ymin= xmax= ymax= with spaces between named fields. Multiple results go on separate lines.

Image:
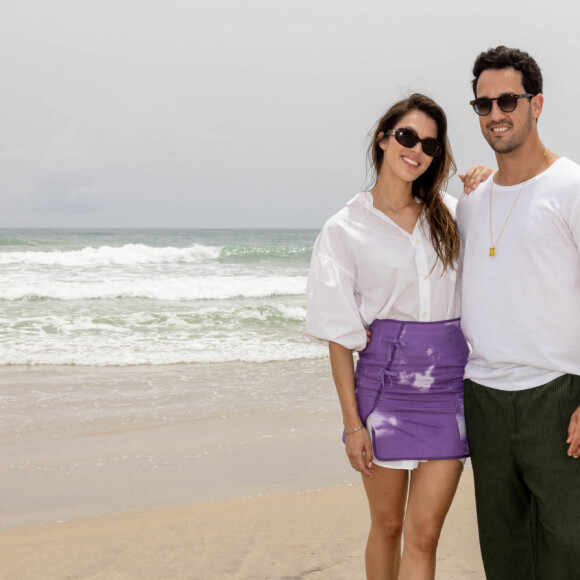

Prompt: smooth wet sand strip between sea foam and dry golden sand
xmin=0 ymin=361 xmax=358 ymax=529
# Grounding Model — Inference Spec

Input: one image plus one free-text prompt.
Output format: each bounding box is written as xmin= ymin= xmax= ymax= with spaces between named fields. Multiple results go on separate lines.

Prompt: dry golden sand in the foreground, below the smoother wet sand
xmin=0 ymin=470 xmax=485 ymax=580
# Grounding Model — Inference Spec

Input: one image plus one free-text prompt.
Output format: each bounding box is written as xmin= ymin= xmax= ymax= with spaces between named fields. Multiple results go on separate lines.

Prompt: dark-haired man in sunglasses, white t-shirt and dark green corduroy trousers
xmin=457 ymin=46 xmax=580 ymax=580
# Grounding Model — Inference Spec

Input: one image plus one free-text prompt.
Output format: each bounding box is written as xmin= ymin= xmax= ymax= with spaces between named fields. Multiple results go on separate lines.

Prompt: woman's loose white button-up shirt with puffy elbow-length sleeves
xmin=305 ymin=192 xmax=459 ymax=350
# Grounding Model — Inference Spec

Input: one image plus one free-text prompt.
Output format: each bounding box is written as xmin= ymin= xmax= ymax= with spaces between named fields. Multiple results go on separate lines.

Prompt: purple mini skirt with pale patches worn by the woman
xmin=356 ymin=318 xmax=469 ymax=461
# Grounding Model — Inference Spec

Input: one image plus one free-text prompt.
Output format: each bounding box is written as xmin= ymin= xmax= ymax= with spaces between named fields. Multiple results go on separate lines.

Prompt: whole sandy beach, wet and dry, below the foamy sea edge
xmin=0 ymin=361 xmax=484 ymax=580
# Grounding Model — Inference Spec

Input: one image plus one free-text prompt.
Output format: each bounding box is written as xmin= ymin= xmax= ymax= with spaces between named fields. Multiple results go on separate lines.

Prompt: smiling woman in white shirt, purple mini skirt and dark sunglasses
xmin=306 ymin=94 xmax=469 ymax=580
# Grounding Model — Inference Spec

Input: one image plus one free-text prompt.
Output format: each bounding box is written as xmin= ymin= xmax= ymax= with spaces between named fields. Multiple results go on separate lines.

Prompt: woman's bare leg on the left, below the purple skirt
xmin=363 ymin=465 xmax=409 ymax=580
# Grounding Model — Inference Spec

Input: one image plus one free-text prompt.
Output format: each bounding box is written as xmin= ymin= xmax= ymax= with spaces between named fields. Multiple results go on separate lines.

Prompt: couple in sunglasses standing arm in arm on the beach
xmin=306 ymin=46 xmax=580 ymax=580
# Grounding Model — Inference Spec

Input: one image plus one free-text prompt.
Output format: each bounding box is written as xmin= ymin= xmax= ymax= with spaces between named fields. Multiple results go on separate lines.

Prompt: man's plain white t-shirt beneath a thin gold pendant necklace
xmin=457 ymin=158 xmax=580 ymax=391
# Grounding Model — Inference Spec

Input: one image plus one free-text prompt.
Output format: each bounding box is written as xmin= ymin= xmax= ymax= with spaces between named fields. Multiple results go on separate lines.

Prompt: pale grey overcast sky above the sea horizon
xmin=0 ymin=0 xmax=580 ymax=228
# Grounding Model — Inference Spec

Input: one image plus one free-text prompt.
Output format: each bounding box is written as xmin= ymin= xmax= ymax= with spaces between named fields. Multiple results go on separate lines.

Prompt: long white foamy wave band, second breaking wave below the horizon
xmin=0 ymin=276 xmax=306 ymax=301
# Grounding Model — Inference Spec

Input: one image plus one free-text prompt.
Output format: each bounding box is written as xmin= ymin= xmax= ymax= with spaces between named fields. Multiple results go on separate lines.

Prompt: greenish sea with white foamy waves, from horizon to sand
xmin=0 ymin=229 xmax=327 ymax=366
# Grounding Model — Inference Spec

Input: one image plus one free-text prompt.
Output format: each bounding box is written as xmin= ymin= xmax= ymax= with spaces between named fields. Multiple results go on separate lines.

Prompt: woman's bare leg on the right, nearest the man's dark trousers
xmin=398 ymin=459 xmax=463 ymax=580
